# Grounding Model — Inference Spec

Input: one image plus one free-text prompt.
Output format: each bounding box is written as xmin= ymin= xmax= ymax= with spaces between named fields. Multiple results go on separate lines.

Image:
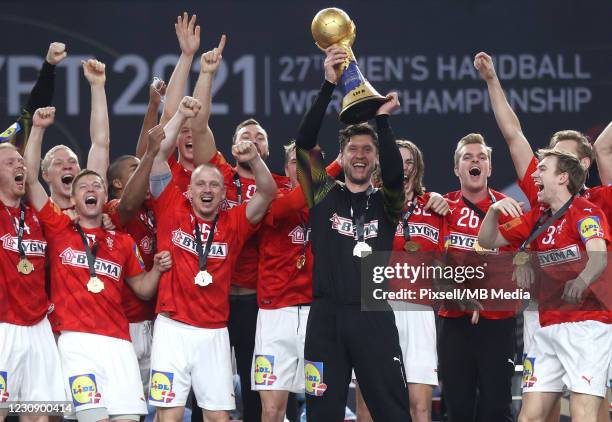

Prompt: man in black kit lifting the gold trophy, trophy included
xmin=296 ymin=9 xmax=410 ymax=422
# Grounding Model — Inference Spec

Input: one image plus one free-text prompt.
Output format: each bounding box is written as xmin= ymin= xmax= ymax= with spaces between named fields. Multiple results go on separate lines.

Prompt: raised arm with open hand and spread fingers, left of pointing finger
xmin=160 ymin=12 xmax=200 ymax=125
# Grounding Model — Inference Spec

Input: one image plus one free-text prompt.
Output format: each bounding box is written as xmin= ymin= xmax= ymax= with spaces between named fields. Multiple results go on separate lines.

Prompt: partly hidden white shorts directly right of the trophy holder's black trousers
xmin=392 ymin=302 xmax=438 ymax=386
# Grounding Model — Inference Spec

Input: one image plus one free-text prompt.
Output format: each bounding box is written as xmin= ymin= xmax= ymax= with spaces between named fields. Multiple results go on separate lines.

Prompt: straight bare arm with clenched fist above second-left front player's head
xmin=83 ymin=59 xmax=110 ymax=180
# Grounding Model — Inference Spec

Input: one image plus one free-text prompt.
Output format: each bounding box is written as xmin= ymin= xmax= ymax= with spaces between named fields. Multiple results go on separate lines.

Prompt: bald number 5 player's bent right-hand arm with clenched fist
xmin=232 ymin=141 xmax=277 ymax=224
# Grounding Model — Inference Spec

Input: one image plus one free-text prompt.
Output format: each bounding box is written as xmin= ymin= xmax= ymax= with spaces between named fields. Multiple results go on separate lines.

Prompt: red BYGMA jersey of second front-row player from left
xmin=38 ymin=201 xmax=144 ymax=341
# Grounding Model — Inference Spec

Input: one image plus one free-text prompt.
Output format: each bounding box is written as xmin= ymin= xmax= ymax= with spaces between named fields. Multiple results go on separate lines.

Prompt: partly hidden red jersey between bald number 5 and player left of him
xmin=104 ymin=199 xmax=156 ymax=322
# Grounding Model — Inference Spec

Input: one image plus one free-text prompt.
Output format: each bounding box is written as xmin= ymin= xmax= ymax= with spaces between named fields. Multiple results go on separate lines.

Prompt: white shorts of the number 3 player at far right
xmin=523 ymin=321 xmax=612 ymax=397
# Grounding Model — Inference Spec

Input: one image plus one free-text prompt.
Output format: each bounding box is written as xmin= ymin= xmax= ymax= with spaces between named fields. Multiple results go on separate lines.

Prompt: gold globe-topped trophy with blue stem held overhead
xmin=310 ymin=7 xmax=387 ymax=125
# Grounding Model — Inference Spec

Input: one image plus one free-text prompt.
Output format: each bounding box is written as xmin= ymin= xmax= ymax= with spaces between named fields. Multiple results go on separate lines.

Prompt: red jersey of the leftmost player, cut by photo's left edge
xmin=0 ymin=202 xmax=49 ymax=325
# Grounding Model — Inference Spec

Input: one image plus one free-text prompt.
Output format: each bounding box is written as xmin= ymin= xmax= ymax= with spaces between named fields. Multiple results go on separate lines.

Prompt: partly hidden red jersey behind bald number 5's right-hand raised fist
xmin=210 ymin=152 xmax=289 ymax=289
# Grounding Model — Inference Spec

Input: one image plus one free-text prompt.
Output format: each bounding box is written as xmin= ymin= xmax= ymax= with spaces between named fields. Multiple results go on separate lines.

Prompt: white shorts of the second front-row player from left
xmin=58 ymin=331 xmax=147 ymax=416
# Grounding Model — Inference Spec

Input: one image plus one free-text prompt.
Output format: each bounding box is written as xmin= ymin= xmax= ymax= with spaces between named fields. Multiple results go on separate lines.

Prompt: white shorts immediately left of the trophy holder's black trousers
xmin=251 ymin=306 xmax=310 ymax=393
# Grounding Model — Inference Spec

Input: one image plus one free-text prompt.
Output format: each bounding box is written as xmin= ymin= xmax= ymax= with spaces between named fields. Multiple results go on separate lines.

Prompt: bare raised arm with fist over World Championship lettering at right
xmin=474 ymin=52 xmax=533 ymax=180
